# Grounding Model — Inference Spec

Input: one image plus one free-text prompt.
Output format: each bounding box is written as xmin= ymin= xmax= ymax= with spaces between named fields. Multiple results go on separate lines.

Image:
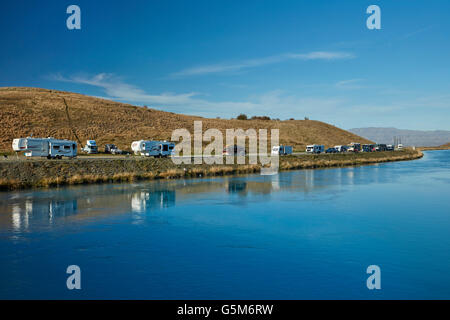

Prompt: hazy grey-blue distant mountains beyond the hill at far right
xmin=348 ymin=128 xmax=450 ymax=147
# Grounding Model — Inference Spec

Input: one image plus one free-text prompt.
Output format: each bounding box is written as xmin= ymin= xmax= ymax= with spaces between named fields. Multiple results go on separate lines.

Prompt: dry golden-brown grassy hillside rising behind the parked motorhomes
xmin=0 ymin=87 xmax=370 ymax=151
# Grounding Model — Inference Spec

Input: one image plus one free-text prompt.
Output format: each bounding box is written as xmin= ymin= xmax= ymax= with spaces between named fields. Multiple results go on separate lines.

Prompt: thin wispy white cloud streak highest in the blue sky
xmin=170 ymin=51 xmax=355 ymax=78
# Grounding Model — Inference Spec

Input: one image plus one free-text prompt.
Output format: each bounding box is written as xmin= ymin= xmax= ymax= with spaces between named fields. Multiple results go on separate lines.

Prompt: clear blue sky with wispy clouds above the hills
xmin=0 ymin=0 xmax=450 ymax=130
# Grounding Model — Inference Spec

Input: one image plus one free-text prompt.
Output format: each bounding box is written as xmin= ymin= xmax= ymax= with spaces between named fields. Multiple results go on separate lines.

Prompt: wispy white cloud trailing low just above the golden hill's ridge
xmin=50 ymin=73 xmax=343 ymax=118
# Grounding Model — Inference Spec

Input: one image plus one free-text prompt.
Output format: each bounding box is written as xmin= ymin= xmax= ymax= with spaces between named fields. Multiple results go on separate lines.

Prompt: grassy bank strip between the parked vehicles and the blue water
xmin=0 ymin=150 xmax=423 ymax=190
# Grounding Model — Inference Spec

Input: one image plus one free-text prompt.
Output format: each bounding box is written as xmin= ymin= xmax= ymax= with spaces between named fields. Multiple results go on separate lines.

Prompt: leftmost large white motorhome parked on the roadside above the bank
xmin=12 ymin=137 xmax=77 ymax=159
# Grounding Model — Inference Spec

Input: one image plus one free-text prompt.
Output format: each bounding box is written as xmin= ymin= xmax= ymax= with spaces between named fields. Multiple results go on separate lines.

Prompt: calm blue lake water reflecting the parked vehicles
xmin=0 ymin=151 xmax=450 ymax=299
